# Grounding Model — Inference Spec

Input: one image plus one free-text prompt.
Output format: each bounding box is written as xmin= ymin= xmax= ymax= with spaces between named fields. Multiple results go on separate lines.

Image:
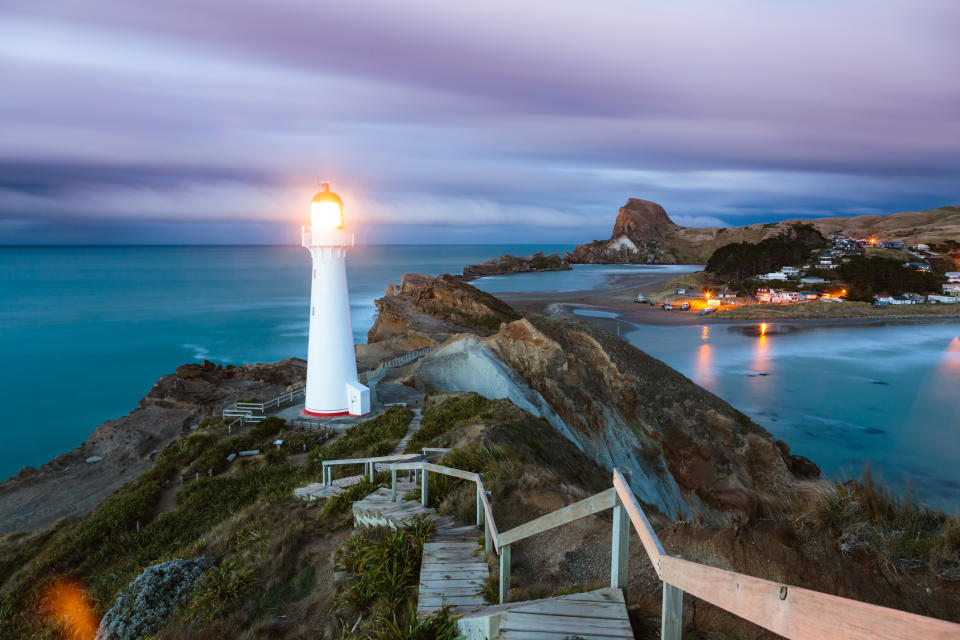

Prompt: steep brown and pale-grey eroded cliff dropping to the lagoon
xmin=371 ymin=276 xmax=819 ymax=521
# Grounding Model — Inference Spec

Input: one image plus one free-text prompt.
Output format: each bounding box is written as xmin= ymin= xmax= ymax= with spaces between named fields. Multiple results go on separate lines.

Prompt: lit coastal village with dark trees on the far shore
xmin=652 ymin=231 xmax=960 ymax=315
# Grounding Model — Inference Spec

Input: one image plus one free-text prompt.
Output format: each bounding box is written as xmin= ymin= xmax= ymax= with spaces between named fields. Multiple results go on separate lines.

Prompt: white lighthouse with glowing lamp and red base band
xmin=302 ymin=182 xmax=370 ymax=418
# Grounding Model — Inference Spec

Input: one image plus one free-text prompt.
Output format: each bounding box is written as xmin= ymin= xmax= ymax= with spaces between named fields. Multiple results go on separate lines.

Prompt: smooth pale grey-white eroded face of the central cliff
xmin=417 ymin=335 xmax=691 ymax=515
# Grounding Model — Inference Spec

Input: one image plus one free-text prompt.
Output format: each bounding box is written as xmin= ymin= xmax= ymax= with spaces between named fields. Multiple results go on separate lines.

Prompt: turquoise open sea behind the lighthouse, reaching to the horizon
xmin=0 ymin=245 xmax=572 ymax=478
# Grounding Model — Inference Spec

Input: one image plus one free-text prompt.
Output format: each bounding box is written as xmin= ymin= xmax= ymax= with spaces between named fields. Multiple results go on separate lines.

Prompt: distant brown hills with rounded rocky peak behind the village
xmin=564 ymin=198 xmax=960 ymax=264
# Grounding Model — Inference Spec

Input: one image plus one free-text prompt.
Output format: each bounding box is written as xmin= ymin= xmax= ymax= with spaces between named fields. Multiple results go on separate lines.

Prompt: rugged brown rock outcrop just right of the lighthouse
xmin=356 ymin=273 xmax=520 ymax=369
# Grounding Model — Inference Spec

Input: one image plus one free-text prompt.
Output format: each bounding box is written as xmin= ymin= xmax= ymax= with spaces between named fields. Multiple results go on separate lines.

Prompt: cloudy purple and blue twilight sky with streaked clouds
xmin=0 ymin=0 xmax=960 ymax=244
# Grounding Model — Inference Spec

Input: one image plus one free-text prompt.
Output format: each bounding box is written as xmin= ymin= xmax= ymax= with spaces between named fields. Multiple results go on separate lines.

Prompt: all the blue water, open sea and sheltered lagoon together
xmin=0 ymin=245 xmax=960 ymax=512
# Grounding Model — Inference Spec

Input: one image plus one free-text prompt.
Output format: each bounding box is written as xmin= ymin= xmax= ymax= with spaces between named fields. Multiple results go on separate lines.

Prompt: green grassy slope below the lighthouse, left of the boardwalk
xmin=0 ymin=407 xmax=413 ymax=638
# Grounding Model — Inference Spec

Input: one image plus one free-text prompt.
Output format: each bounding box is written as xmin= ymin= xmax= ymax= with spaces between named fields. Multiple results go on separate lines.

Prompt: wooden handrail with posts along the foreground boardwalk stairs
xmin=376 ymin=461 xmax=960 ymax=640
